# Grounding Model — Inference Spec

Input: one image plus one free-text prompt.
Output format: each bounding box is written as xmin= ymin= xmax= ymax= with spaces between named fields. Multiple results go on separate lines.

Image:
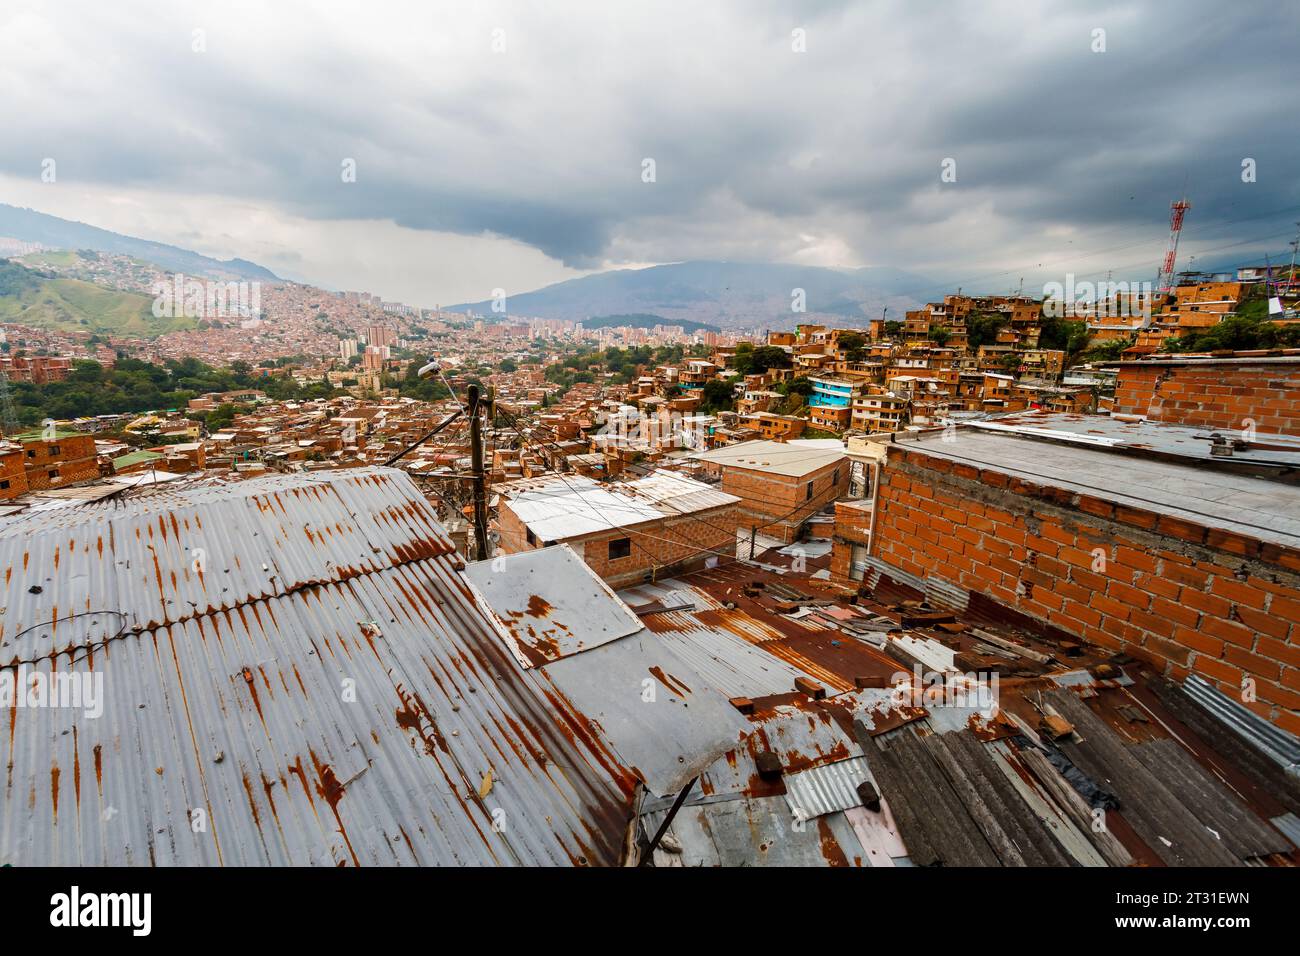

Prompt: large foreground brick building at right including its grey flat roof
xmin=872 ymin=415 xmax=1300 ymax=734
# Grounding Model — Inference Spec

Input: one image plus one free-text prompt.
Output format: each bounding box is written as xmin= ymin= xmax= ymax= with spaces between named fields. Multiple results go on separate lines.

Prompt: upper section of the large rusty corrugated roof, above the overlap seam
xmin=0 ymin=468 xmax=454 ymax=663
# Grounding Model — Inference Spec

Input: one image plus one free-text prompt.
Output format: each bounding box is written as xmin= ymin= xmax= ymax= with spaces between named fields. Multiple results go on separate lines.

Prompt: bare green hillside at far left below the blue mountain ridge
xmin=0 ymin=261 xmax=198 ymax=338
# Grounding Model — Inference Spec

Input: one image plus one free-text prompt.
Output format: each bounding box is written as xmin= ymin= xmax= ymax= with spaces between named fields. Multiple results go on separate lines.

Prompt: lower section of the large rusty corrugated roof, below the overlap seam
xmin=0 ymin=562 xmax=628 ymax=865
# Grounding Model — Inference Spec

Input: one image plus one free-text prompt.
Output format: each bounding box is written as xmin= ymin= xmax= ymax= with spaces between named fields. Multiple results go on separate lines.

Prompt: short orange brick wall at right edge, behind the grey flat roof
xmin=1114 ymin=360 xmax=1300 ymax=434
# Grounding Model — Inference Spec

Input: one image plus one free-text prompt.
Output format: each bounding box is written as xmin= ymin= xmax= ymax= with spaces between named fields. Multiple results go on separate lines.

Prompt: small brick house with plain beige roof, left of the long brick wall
xmin=694 ymin=440 xmax=849 ymax=544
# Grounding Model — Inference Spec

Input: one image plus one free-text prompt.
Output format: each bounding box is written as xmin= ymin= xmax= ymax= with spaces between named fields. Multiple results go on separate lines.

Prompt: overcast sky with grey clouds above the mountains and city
xmin=0 ymin=0 xmax=1300 ymax=306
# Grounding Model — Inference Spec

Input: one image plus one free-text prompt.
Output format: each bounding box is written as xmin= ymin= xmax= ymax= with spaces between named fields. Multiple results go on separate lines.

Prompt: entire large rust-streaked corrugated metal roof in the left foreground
xmin=0 ymin=468 xmax=650 ymax=865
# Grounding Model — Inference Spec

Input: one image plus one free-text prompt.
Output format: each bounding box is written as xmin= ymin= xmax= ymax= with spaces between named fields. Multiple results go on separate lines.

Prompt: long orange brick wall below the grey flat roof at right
xmin=875 ymin=445 xmax=1300 ymax=734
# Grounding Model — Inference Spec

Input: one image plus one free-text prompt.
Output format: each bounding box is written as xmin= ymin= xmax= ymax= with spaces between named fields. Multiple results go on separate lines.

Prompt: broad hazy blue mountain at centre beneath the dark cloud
xmin=445 ymin=261 xmax=941 ymax=329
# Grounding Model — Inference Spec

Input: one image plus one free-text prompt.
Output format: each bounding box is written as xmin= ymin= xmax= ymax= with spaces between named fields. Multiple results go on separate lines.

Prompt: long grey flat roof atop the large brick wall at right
xmin=898 ymin=429 xmax=1300 ymax=548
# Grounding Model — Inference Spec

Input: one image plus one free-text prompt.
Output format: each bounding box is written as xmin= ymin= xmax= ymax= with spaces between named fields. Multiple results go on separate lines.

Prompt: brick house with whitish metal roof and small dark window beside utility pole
xmin=493 ymin=471 xmax=740 ymax=587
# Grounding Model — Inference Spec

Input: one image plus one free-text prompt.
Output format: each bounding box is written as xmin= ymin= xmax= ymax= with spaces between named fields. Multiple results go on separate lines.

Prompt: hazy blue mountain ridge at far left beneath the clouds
xmin=0 ymin=203 xmax=280 ymax=282
